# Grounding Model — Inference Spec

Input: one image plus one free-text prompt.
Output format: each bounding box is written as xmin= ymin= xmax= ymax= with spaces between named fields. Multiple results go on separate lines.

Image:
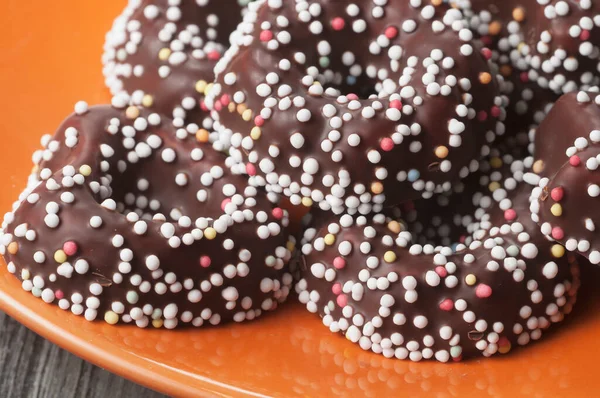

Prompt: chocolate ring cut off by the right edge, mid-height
xmin=528 ymin=91 xmax=600 ymax=264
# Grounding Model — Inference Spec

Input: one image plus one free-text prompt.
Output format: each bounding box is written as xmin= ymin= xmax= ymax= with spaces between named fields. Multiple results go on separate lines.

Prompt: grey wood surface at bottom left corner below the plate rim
xmin=0 ymin=312 xmax=162 ymax=398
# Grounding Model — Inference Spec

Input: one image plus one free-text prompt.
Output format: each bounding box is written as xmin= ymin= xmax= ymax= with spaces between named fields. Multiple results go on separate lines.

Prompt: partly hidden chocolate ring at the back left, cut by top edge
xmin=102 ymin=0 xmax=249 ymax=149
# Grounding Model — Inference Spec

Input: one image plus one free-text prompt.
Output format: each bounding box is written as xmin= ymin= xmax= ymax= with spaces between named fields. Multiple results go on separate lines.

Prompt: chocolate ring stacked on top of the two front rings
xmin=207 ymin=0 xmax=504 ymax=214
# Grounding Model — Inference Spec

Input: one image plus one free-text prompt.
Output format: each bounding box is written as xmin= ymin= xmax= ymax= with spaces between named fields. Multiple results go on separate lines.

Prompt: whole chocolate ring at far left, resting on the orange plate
xmin=0 ymin=103 xmax=294 ymax=328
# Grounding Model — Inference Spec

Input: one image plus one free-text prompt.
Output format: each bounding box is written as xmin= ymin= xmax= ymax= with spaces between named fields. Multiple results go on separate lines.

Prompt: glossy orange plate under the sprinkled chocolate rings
xmin=0 ymin=0 xmax=600 ymax=397
